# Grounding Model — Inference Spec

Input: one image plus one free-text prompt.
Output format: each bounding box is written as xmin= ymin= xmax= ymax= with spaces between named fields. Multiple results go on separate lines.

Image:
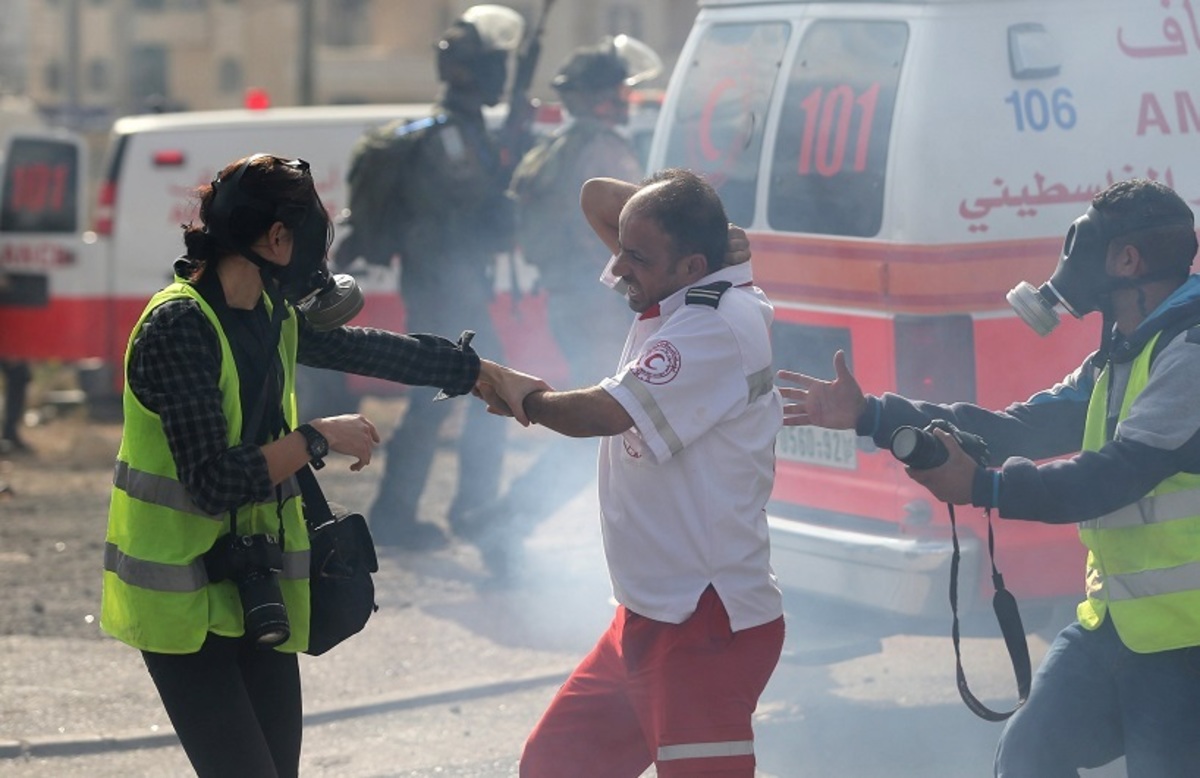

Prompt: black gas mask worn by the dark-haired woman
xmin=209 ymin=154 xmax=364 ymax=330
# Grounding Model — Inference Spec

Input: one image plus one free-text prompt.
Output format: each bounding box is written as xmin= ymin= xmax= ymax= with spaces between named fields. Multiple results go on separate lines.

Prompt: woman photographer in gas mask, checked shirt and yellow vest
xmin=101 ymin=155 xmax=542 ymax=776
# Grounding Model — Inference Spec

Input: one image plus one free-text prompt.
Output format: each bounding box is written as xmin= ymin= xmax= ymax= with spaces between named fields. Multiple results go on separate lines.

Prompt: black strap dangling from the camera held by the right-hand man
xmin=947 ymin=503 xmax=1032 ymax=722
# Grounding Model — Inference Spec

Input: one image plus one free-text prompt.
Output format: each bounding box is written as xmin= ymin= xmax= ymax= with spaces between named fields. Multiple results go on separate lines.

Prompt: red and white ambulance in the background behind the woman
xmin=0 ymin=104 xmax=565 ymax=415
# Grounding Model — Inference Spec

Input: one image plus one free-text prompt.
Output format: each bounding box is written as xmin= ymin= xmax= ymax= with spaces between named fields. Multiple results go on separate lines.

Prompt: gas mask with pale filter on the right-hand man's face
xmin=1006 ymin=207 xmax=1187 ymax=335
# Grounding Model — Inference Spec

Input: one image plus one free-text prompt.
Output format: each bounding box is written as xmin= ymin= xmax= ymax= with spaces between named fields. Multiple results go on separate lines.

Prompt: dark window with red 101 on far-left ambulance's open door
xmin=0 ymin=138 xmax=79 ymax=233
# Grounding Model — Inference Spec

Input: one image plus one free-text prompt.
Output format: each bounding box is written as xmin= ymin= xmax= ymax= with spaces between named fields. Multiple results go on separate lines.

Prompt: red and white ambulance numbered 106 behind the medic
xmin=649 ymin=0 xmax=1200 ymax=634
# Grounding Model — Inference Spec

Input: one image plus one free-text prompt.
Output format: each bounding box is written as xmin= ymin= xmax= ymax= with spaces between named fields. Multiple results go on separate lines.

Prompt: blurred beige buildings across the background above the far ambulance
xmin=16 ymin=0 xmax=696 ymax=131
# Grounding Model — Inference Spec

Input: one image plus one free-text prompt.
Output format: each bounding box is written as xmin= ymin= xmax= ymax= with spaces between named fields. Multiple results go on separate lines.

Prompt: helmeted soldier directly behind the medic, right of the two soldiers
xmin=454 ymin=35 xmax=662 ymax=577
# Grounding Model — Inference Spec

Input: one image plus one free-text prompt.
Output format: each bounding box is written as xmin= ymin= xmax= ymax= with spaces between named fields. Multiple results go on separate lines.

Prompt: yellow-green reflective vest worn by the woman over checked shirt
xmin=100 ymin=281 xmax=308 ymax=653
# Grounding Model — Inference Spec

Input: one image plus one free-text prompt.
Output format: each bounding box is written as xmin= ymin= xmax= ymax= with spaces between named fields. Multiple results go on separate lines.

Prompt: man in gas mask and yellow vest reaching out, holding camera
xmin=779 ymin=180 xmax=1200 ymax=778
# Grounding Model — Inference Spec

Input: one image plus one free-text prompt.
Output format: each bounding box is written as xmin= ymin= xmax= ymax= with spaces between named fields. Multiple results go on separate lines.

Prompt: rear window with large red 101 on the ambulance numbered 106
xmin=768 ymin=20 xmax=908 ymax=237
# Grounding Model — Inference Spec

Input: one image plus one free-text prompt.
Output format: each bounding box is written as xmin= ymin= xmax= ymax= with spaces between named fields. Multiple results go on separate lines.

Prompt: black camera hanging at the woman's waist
xmin=205 ymin=534 xmax=292 ymax=648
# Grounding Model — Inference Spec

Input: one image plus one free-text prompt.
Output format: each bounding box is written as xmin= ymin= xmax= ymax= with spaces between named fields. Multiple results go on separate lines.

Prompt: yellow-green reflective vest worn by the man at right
xmin=1078 ymin=335 xmax=1200 ymax=653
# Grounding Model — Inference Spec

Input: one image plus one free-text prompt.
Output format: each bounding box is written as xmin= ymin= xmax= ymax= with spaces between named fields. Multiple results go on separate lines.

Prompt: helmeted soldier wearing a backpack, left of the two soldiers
xmin=355 ymin=5 xmax=523 ymax=550
